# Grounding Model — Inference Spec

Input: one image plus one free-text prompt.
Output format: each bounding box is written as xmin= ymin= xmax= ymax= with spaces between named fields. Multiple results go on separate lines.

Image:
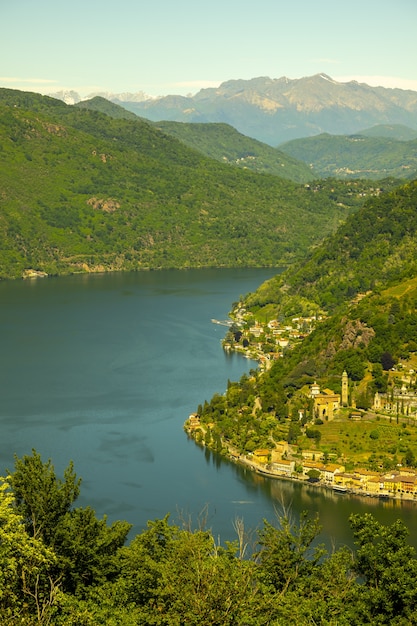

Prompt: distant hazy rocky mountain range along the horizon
xmin=51 ymin=74 xmax=417 ymax=146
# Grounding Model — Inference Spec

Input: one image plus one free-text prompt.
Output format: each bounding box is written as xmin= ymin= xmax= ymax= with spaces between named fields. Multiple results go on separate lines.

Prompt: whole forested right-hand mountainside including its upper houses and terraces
xmin=194 ymin=181 xmax=417 ymax=470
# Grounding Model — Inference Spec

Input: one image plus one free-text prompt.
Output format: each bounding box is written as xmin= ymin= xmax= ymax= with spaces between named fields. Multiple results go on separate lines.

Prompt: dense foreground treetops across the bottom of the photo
xmin=0 ymin=451 xmax=417 ymax=626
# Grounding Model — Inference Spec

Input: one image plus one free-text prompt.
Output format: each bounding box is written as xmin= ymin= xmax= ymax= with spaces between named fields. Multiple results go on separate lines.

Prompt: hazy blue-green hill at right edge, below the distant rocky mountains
xmin=280 ymin=130 xmax=417 ymax=180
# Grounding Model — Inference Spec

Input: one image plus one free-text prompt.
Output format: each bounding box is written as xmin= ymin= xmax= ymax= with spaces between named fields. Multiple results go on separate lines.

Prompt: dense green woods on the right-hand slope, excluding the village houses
xmin=194 ymin=182 xmax=417 ymax=458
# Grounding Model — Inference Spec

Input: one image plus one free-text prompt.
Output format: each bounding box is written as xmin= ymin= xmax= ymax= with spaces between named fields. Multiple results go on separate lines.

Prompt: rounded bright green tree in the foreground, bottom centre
xmin=112 ymin=516 xmax=254 ymax=626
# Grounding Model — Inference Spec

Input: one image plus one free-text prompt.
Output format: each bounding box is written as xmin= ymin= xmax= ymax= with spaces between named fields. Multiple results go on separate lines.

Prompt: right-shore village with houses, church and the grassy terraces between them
xmin=184 ymin=308 xmax=417 ymax=500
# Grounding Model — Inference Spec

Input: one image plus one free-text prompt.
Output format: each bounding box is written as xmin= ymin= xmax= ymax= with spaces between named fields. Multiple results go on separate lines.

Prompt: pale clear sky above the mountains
xmin=0 ymin=0 xmax=417 ymax=97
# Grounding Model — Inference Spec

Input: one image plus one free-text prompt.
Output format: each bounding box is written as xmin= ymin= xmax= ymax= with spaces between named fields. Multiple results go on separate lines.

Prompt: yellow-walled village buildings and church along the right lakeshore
xmin=184 ymin=308 xmax=417 ymax=501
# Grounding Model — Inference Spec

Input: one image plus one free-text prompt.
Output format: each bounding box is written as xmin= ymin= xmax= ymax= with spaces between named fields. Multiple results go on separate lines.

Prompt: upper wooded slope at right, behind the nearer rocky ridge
xmin=247 ymin=181 xmax=417 ymax=317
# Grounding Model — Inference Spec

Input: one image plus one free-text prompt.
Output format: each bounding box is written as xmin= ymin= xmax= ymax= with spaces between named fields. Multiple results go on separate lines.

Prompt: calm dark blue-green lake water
xmin=0 ymin=270 xmax=417 ymax=545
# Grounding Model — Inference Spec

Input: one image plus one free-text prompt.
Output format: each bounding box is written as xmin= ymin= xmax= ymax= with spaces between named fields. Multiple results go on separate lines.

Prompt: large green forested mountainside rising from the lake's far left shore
xmin=0 ymin=89 xmax=384 ymax=278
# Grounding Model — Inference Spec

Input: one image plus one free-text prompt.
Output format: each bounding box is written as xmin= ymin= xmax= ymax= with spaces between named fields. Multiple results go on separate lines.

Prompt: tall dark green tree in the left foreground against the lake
xmin=9 ymin=450 xmax=131 ymax=594
